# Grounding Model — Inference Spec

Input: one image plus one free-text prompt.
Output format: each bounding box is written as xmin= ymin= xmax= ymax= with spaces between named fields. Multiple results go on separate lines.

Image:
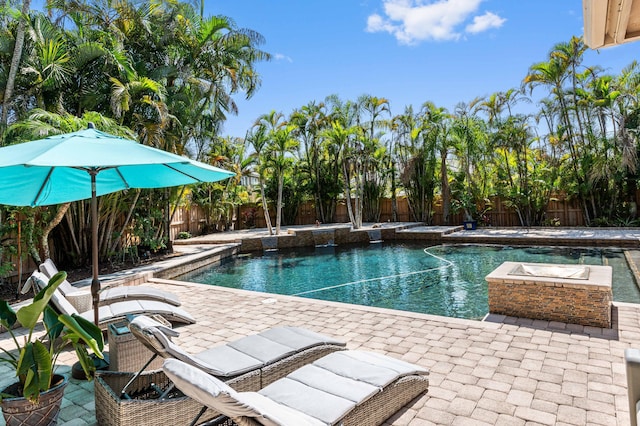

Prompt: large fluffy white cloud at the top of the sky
xmin=367 ymin=0 xmax=506 ymax=44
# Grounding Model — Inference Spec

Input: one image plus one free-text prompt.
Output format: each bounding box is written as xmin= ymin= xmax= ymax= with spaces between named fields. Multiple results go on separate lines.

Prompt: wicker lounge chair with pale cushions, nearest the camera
xmin=163 ymin=351 xmax=429 ymax=426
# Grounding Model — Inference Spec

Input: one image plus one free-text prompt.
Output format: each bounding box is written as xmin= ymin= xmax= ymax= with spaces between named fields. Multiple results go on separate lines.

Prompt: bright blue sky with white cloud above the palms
xmin=205 ymin=0 xmax=640 ymax=137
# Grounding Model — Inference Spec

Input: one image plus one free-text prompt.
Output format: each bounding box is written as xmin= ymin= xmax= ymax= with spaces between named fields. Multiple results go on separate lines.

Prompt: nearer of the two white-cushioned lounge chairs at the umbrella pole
xmin=28 ymin=271 xmax=196 ymax=330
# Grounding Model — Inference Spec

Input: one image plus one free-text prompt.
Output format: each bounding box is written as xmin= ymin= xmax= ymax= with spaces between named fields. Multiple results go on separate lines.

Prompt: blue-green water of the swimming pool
xmin=178 ymin=244 xmax=640 ymax=319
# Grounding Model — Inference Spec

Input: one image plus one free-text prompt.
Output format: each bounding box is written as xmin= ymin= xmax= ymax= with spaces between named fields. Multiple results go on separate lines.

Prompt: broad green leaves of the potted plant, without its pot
xmin=0 ymin=272 xmax=104 ymax=403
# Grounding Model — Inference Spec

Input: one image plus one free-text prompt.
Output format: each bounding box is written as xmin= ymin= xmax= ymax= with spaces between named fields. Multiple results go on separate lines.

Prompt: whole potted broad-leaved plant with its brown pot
xmin=0 ymin=272 xmax=104 ymax=426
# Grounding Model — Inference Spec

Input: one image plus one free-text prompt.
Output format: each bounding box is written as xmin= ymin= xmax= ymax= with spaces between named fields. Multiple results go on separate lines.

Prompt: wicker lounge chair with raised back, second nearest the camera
xmin=95 ymin=315 xmax=346 ymax=426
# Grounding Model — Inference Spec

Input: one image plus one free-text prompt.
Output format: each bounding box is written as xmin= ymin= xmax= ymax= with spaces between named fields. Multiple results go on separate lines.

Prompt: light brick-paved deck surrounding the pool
xmin=0 ymin=228 xmax=640 ymax=426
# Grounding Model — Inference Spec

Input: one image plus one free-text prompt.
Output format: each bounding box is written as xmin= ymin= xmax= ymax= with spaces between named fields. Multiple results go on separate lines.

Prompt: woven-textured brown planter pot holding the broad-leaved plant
xmin=0 ymin=374 xmax=69 ymax=426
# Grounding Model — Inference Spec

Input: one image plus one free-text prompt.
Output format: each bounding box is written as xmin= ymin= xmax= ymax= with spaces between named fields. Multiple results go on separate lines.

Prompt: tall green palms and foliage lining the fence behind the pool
xmin=0 ymin=0 xmax=640 ymax=256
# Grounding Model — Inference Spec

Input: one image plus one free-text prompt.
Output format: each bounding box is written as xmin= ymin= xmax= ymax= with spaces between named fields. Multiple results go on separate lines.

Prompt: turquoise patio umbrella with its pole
xmin=0 ymin=124 xmax=234 ymax=324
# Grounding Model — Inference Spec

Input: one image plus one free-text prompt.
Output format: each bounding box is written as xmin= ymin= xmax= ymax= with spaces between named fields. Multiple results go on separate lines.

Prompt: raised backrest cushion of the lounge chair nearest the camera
xmin=162 ymin=358 xmax=323 ymax=426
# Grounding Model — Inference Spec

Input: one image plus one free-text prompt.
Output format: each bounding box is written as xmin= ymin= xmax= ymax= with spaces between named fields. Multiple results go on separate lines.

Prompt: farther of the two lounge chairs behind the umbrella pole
xmin=39 ymin=259 xmax=180 ymax=312
